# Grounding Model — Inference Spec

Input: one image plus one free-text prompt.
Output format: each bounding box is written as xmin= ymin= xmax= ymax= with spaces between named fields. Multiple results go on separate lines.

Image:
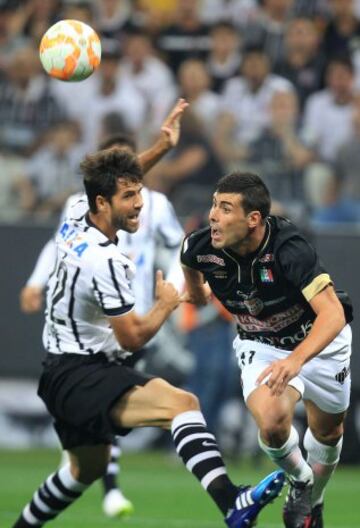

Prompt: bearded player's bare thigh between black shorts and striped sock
xmin=110 ymin=378 xmax=199 ymax=428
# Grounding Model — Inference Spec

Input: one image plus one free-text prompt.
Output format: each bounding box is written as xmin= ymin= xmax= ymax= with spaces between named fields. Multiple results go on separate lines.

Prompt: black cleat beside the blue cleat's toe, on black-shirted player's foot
xmin=283 ymin=479 xmax=312 ymax=528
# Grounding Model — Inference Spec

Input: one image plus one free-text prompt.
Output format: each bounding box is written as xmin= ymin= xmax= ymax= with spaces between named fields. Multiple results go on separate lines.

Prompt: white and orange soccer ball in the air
xmin=40 ymin=20 xmax=101 ymax=81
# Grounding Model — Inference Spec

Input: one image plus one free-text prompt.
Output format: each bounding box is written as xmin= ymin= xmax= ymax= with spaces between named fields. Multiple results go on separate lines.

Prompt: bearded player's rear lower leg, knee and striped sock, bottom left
xmin=13 ymin=444 xmax=109 ymax=528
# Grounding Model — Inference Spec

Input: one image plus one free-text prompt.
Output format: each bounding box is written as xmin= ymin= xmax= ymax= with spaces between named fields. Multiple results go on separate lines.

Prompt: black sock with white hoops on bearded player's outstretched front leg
xmin=171 ymin=411 xmax=238 ymax=515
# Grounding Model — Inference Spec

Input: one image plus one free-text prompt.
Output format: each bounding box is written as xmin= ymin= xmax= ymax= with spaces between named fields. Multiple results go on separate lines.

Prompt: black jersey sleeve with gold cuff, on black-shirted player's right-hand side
xmin=278 ymin=236 xmax=332 ymax=302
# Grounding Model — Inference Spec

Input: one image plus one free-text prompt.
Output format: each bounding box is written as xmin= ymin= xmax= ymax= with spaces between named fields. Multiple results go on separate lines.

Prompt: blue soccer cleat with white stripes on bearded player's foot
xmin=225 ymin=470 xmax=285 ymax=528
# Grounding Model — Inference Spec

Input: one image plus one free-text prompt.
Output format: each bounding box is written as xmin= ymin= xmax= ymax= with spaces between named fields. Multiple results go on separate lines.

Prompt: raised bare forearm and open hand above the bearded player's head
xmin=138 ymin=99 xmax=189 ymax=174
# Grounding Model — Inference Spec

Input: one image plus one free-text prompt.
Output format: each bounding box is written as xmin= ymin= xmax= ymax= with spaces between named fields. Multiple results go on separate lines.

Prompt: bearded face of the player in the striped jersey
xmin=110 ymin=178 xmax=143 ymax=233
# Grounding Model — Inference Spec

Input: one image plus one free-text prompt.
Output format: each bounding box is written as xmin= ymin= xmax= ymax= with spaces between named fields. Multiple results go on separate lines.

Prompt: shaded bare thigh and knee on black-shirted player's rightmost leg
xmin=304 ymin=400 xmax=346 ymax=445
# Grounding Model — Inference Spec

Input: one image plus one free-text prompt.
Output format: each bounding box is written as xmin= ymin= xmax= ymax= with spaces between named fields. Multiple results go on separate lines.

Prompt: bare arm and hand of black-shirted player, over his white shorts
xmin=257 ymin=285 xmax=346 ymax=395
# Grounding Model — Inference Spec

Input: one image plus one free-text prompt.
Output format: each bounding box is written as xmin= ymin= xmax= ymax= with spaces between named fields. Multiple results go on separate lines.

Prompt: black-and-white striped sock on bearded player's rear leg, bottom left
xmin=13 ymin=464 xmax=88 ymax=528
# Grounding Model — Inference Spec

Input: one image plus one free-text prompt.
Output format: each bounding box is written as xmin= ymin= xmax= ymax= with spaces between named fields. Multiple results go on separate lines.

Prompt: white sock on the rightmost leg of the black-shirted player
xmin=304 ymin=428 xmax=343 ymax=506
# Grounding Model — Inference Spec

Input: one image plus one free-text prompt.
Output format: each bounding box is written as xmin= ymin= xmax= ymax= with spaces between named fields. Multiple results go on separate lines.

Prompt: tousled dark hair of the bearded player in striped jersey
xmin=80 ymin=147 xmax=143 ymax=213
